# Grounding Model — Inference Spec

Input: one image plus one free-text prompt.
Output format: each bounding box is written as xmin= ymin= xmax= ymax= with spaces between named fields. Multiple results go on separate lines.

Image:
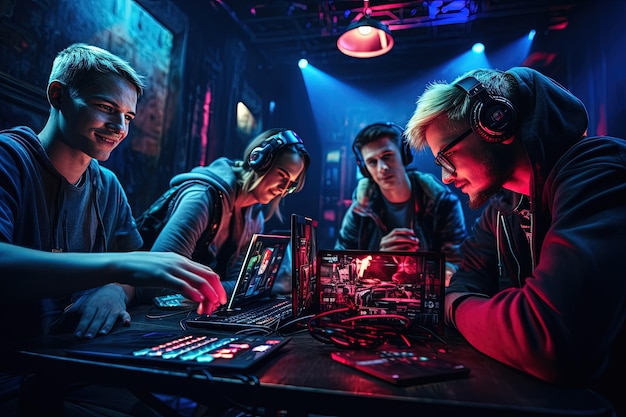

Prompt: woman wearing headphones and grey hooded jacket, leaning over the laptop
xmin=140 ymin=129 xmax=310 ymax=301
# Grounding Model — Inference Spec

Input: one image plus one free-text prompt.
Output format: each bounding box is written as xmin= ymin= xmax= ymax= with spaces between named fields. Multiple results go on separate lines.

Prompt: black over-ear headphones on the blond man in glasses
xmin=455 ymin=77 xmax=517 ymax=143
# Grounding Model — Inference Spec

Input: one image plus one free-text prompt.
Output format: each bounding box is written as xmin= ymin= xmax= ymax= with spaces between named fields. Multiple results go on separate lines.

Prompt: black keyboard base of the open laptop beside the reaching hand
xmin=186 ymin=299 xmax=292 ymax=329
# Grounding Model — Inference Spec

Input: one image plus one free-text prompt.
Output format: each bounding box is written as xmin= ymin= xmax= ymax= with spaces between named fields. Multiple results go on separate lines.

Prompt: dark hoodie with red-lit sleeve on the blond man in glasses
xmin=446 ymin=68 xmax=626 ymax=394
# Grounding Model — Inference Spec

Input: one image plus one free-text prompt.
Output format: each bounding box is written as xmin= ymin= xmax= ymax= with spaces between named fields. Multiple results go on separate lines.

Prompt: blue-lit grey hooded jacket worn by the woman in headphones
xmin=152 ymin=158 xmax=264 ymax=280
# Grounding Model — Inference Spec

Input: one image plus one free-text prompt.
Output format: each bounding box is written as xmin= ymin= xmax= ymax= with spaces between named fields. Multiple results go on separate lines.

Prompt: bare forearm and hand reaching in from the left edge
xmin=0 ymin=242 xmax=227 ymax=319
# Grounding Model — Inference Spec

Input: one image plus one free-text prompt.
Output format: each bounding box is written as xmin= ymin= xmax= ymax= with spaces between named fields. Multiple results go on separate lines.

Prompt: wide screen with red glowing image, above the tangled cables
xmin=317 ymin=250 xmax=445 ymax=335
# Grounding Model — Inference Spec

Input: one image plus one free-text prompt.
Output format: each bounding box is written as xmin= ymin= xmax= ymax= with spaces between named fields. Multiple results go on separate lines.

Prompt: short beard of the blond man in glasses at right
xmin=469 ymin=144 xmax=515 ymax=210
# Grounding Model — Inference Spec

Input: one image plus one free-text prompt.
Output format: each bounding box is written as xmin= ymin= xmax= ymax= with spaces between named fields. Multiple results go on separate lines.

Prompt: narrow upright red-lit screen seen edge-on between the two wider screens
xmin=291 ymin=214 xmax=318 ymax=317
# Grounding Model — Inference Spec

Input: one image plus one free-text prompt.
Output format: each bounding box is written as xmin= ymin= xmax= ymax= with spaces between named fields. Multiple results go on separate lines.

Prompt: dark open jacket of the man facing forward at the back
xmin=335 ymin=171 xmax=467 ymax=263
